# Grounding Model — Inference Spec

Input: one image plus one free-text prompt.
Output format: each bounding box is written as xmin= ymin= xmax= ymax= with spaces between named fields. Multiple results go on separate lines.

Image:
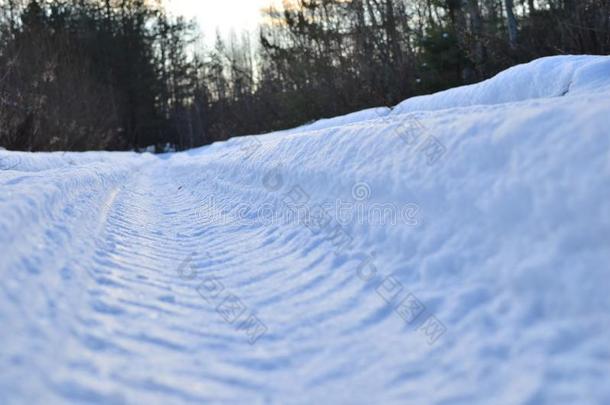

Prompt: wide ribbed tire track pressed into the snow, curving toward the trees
xmin=1 ymin=156 xmax=418 ymax=403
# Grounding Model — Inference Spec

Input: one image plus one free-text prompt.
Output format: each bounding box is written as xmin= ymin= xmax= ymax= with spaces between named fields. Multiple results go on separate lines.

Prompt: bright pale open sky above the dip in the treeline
xmin=165 ymin=0 xmax=278 ymax=44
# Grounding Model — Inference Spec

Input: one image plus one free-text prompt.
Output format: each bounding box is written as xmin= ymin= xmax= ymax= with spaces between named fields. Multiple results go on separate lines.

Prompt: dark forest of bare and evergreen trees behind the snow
xmin=0 ymin=0 xmax=610 ymax=151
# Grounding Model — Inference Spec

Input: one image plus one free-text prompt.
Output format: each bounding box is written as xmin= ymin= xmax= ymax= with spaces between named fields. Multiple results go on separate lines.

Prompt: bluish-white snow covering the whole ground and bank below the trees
xmin=0 ymin=56 xmax=610 ymax=404
